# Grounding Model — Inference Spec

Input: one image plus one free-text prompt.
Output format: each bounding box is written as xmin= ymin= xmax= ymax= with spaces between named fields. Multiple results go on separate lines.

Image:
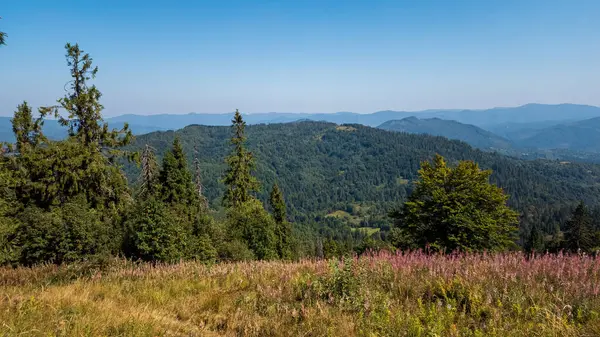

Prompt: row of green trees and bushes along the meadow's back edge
xmin=0 ymin=44 xmax=597 ymax=265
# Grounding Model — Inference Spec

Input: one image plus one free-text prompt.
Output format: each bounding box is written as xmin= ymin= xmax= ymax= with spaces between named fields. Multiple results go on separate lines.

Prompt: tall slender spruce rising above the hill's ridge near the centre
xmin=223 ymin=110 xmax=259 ymax=207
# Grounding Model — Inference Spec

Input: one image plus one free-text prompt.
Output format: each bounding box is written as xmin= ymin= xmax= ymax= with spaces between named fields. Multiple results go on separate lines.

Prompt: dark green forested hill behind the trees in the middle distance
xmin=128 ymin=122 xmax=600 ymax=228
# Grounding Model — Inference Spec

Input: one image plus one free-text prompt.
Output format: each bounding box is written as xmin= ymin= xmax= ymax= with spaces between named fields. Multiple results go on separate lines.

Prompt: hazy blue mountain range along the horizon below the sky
xmin=0 ymin=104 xmax=600 ymax=158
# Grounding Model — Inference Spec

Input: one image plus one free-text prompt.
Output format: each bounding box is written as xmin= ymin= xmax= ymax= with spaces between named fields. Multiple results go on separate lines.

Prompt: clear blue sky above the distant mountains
xmin=0 ymin=0 xmax=600 ymax=116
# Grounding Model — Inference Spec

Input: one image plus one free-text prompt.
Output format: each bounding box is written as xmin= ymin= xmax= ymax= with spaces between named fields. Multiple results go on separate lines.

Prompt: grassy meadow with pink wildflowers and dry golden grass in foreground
xmin=0 ymin=252 xmax=600 ymax=336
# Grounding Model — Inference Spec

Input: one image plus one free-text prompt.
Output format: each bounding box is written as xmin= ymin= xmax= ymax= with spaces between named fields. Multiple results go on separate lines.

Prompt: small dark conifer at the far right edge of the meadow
xmin=565 ymin=202 xmax=595 ymax=252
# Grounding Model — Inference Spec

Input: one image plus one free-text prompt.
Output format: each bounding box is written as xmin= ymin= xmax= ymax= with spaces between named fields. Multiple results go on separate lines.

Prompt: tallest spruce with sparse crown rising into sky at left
xmin=19 ymin=44 xmax=132 ymax=211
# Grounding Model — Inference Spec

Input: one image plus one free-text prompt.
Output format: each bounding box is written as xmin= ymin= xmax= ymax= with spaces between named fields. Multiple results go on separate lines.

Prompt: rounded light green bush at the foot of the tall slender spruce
xmin=227 ymin=199 xmax=278 ymax=260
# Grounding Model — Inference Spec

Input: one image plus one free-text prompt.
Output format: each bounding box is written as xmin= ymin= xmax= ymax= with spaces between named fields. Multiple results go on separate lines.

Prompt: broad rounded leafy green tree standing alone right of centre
xmin=394 ymin=155 xmax=518 ymax=251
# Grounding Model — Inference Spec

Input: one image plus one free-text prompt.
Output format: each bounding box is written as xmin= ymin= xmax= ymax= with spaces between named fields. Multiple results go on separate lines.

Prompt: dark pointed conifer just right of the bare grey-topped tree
xmin=159 ymin=137 xmax=198 ymax=206
